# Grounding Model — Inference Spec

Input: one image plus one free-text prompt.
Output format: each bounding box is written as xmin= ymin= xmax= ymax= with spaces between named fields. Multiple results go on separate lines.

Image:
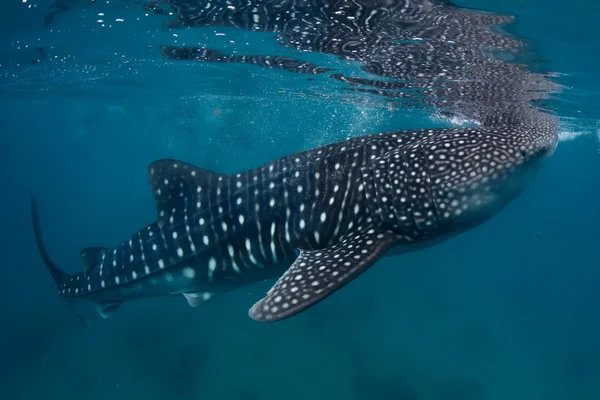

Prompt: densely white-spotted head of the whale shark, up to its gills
xmin=362 ymin=115 xmax=557 ymax=240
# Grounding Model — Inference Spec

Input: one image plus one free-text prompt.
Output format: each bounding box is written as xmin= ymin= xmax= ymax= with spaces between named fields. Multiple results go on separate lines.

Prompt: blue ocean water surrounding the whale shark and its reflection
xmin=0 ymin=0 xmax=600 ymax=400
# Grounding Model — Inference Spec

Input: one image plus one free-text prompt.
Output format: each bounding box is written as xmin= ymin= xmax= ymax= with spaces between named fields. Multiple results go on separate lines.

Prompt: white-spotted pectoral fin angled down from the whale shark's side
xmin=248 ymin=228 xmax=398 ymax=322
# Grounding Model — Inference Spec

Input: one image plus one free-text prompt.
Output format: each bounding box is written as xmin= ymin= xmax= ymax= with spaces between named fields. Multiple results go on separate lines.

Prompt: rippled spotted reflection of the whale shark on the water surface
xmin=154 ymin=0 xmax=559 ymax=125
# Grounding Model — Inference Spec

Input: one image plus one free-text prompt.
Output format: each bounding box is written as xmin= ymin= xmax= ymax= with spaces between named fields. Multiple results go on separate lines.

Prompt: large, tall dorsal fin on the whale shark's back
xmin=148 ymin=159 xmax=227 ymax=229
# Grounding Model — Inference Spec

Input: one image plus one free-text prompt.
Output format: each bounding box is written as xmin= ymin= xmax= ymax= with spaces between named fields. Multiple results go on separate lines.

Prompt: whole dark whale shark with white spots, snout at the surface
xmin=31 ymin=114 xmax=557 ymax=322
